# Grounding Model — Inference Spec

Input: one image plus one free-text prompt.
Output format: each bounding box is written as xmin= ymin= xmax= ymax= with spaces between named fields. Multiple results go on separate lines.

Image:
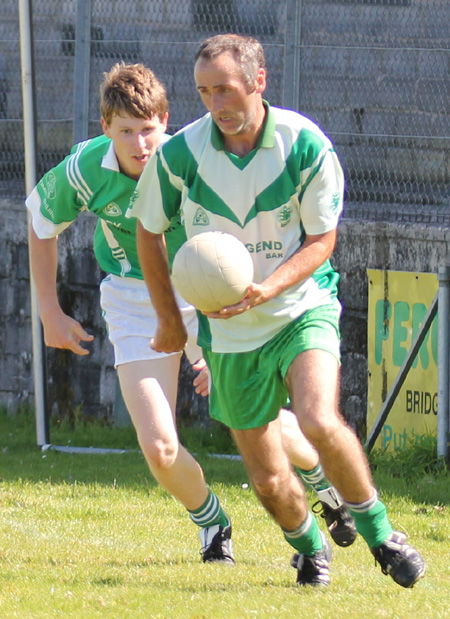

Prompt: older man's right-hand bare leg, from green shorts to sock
xmin=286 ymin=350 xmax=374 ymax=503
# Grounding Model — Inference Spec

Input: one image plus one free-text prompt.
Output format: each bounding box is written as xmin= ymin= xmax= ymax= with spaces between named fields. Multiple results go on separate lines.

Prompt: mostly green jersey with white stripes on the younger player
xmin=26 ymin=135 xmax=186 ymax=279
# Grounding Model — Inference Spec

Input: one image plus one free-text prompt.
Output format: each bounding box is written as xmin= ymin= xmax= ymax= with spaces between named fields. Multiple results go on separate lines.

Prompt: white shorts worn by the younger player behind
xmin=100 ymin=275 xmax=202 ymax=367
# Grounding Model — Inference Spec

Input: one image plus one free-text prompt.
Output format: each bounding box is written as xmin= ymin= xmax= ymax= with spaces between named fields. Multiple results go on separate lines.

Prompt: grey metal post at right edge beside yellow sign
xmin=437 ymin=266 xmax=450 ymax=458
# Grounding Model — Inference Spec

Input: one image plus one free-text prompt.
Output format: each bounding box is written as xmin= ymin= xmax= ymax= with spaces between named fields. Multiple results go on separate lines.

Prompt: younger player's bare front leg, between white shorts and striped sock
xmin=118 ymin=355 xmax=208 ymax=510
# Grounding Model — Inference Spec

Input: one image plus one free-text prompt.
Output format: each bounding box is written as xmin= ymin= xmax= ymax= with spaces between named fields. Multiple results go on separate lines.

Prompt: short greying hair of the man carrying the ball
xmin=195 ymin=34 xmax=266 ymax=92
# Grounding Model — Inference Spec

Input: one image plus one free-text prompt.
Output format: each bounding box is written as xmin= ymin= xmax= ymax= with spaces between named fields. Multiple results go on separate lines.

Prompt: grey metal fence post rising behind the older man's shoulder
xmin=282 ymin=0 xmax=302 ymax=111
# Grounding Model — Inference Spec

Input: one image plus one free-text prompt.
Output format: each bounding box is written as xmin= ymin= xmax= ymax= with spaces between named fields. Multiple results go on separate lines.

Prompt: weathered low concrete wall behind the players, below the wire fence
xmin=0 ymin=200 xmax=450 ymax=436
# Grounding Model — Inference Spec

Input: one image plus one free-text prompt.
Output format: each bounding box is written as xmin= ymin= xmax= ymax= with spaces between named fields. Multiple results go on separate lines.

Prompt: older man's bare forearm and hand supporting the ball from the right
xmin=207 ymin=229 xmax=337 ymax=318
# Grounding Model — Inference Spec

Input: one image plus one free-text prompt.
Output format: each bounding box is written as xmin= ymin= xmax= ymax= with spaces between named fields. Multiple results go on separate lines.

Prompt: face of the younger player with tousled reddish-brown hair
xmin=101 ymin=114 xmax=168 ymax=180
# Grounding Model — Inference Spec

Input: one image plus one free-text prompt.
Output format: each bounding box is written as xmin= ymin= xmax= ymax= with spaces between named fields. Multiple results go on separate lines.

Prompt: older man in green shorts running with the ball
xmin=128 ymin=35 xmax=425 ymax=587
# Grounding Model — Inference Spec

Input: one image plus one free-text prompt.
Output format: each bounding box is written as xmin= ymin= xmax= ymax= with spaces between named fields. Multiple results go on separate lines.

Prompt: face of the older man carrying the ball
xmin=194 ymin=52 xmax=266 ymax=136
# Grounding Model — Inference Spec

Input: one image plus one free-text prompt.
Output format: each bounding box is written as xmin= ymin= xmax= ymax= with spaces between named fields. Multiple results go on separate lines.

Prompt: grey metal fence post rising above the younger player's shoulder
xmin=73 ymin=0 xmax=91 ymax=144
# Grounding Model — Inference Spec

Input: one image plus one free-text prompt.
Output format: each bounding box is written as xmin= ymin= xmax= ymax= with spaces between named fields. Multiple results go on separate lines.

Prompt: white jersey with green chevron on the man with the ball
xmin=127 ymin=102 xmax=344 ymax=353
